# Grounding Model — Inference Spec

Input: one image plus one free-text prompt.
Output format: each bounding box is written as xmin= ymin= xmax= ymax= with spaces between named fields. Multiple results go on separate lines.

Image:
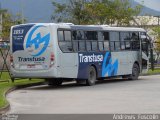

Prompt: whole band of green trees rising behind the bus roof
xmin=52 ymin=0 xmax=142 ymax=26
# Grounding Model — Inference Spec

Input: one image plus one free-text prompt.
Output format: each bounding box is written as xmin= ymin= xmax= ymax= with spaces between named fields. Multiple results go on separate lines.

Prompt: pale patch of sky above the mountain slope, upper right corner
xmin=135 ymin=0 xmax=160 ymax=11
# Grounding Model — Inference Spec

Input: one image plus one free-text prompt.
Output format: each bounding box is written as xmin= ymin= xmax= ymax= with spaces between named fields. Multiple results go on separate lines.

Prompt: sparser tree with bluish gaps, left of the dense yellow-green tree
xmin=52 ymin=0 xmax=89 ymax=24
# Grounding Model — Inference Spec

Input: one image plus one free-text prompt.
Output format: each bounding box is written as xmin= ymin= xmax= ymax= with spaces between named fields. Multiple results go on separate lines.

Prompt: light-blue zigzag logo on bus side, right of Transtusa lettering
xmin=102 ymin=52 xmax=118 ymax=77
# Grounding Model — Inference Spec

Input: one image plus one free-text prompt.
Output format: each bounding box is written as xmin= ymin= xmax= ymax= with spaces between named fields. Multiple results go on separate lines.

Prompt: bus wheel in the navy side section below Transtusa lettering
xmin=86 ymin=66 xmax=97 ymax=86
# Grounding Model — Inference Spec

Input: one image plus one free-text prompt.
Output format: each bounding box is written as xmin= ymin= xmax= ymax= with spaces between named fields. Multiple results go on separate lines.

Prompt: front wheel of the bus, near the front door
xmin=129 ymin=64 xmax=139 ymax=80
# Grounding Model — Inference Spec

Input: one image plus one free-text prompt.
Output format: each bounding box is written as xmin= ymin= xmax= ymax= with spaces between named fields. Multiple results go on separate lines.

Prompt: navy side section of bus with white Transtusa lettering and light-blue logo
xmin=77 ymin=52 xmax=119 ymax=79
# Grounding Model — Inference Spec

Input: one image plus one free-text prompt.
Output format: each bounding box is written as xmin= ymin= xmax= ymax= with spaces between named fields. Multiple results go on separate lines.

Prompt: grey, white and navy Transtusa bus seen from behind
xmin=10 ymin=23 xmax=151 ymax=86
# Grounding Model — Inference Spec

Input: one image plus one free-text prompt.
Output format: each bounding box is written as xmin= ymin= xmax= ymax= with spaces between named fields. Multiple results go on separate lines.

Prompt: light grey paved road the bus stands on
xmin=7 ymin=75 xmax=160 ymax=114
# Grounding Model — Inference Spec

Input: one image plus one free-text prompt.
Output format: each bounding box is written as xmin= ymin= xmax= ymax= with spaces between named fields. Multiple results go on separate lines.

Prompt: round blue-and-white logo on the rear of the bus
xmin=25 ymin=25 xmax=50 ymax=57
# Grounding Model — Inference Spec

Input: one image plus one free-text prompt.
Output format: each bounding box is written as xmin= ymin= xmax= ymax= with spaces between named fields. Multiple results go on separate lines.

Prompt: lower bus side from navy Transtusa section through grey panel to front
xmin=77 ymin=51 xmax=139 ymax=79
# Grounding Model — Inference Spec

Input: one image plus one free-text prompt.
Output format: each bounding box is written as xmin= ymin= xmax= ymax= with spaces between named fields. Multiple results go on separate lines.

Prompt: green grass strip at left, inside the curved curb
xmin=0 ymin=72 xmax=44 ymax=109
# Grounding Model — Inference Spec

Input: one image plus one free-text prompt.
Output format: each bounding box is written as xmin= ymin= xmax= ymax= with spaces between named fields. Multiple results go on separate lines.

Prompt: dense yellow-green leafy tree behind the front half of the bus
xmin=87 ymin=0 xmax=141 ymax=26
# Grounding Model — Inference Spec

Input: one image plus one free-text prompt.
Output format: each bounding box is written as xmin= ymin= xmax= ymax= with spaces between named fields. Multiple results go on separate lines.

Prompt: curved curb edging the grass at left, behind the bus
xmin=0 ymin=82 xmax=45 ymax=115
